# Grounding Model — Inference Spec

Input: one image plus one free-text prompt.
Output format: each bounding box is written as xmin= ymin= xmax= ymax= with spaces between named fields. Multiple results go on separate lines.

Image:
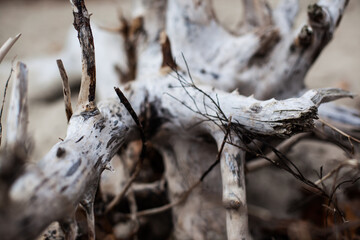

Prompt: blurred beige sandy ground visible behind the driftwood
xmin=0 ymin=0 xmax=360 ymax=159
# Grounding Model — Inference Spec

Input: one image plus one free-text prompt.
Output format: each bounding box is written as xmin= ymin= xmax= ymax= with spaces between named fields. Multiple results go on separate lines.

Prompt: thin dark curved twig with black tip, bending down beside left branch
xmin=106 ymin=87 xmax=146 ymax=212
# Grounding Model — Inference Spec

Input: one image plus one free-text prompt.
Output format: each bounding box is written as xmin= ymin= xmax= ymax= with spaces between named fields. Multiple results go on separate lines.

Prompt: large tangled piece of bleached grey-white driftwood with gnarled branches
xmin=0 ymin=0 xmax=358 ymax=239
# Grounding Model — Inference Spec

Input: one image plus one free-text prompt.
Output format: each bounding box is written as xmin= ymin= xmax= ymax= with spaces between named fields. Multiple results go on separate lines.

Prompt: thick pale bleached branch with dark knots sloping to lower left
xmin=0 ymin=102 xmax=133 ymax=239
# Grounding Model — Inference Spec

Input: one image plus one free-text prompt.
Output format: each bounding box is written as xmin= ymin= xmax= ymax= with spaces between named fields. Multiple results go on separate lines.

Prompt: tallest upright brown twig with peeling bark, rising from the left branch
xmin=70 ymin=0 xmax=96 ymax=112
